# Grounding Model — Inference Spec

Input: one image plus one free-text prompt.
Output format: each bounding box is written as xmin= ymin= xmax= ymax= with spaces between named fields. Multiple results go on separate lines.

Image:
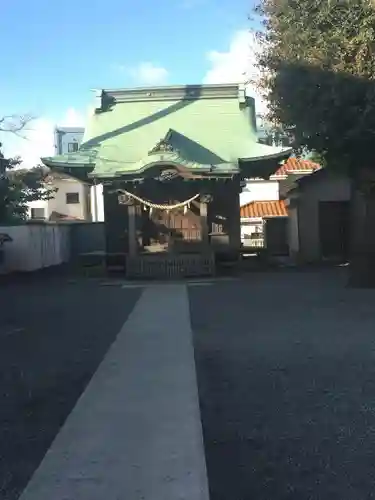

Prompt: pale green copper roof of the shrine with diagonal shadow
xmin=42 ymin=85 xmax=289 ymax=177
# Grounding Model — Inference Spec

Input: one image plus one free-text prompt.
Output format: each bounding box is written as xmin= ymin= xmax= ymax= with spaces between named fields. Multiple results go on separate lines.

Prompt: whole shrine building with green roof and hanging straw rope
xmin=42 ymin=84 xmax=291 ymax=277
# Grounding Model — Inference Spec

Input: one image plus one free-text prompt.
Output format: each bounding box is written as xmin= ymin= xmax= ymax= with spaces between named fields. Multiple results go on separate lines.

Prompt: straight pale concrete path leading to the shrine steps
xmin=20 ymin=285 xmax=208 ymax=500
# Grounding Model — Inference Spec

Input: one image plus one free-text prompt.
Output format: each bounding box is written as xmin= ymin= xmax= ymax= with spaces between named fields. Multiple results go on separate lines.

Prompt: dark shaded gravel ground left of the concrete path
xmin=0 ymin=279 xmax=141 ymax=500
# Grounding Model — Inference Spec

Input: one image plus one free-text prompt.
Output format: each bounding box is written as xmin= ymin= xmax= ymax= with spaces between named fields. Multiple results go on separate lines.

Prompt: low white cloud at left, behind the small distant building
xmin=0 ymin=108 xmax=85 ymax=168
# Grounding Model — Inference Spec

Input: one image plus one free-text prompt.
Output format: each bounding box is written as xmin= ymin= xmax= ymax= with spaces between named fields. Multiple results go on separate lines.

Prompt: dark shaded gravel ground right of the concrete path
xmin=190 ymin=271 xmax=375 ymax=500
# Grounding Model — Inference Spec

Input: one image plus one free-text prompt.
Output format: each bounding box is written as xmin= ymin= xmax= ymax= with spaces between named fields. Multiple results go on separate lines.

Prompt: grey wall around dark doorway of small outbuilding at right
xmin=289 ymin=174 xmax=351 ymax=262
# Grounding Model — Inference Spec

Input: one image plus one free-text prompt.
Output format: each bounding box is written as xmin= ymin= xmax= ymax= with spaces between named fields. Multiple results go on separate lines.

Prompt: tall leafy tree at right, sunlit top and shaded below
xmin=256 ymin=0 xmax=375 ymax=284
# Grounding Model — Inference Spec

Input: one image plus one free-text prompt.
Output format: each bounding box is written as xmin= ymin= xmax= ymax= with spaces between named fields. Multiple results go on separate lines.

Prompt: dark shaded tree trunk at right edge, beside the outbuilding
xmin=348 ymin=173 xmax=375 ymax=288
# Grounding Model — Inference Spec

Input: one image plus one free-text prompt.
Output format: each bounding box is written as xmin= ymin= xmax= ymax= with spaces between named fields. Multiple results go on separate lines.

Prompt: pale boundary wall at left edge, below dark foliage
xmin=0 ymin=224 xmax=70 ymax=274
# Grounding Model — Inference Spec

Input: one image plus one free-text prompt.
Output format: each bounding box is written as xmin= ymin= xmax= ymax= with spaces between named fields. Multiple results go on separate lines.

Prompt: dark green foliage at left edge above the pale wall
xmin=0 ymin=144 xmax=56 ymax=224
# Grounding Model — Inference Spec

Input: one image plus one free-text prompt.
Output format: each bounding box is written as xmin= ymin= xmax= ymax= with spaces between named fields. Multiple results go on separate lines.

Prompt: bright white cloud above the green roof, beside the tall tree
xmin=203 ymin=30 xmax=266 ymax=113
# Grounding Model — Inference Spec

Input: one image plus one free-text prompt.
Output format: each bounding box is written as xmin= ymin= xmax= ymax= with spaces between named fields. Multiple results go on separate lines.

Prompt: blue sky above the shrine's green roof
xmin=0 ymin=0 xmax=260 ymax=164
